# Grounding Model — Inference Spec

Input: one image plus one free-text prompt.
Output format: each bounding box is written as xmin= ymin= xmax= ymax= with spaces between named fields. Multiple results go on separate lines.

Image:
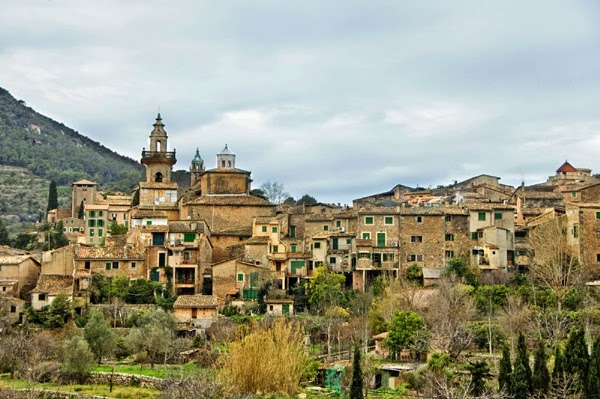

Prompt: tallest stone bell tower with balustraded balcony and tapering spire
xmin=142 ymin=113 xmax=177 ymax=183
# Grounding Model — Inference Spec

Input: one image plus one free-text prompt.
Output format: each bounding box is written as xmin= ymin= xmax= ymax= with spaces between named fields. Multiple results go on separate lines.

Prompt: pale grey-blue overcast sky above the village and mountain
xmin=0 ymin=0 xmax=600 ymax=203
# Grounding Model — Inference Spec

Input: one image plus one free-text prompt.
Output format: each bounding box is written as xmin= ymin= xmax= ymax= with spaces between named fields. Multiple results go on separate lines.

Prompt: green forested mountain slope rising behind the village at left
xmin=0 ymin=88 xmax=144 ymax=233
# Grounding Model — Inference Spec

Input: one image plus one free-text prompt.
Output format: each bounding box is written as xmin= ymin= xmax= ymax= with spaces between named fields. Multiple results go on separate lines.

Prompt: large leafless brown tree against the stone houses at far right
xmin=529 ymin=216 xmax=584 ymax=310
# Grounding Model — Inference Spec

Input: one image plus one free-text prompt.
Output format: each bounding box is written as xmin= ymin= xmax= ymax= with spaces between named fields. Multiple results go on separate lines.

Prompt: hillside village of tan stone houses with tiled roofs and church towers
xmin=0 ymin=114 xmax=600 ymax=398
